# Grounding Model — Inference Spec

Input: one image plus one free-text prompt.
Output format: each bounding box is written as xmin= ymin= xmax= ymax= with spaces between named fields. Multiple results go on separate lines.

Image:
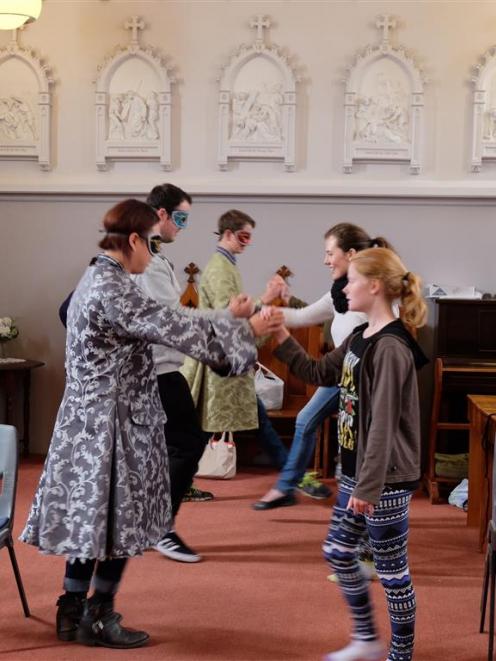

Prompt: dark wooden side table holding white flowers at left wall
xmin=0 ymin=360 xmax=45 ymax=455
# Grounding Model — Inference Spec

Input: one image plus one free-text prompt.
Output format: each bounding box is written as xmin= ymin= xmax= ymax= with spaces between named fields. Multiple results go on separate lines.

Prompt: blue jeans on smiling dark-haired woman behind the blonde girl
xmin=276 ymin=386 xmax=339 ymax=493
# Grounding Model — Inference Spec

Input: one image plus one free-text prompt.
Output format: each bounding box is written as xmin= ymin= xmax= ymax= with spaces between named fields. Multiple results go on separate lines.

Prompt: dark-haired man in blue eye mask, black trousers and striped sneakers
xmin=134 ymin=184 xmax=213 ymax=562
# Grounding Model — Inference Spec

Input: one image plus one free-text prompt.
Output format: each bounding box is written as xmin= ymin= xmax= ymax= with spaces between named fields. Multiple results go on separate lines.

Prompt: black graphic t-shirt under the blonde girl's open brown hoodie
xmin=338 ymin=333 xmax=370 ymax=478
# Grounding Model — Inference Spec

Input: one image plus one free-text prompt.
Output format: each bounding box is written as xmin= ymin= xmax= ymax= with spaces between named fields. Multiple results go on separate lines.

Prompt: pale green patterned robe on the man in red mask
xmin=181 ymin=252 xmax=258 ymax=432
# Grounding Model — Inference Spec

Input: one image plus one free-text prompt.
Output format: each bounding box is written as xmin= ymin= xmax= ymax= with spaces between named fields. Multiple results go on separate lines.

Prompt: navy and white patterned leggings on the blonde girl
xmin=323 ymin=475 xmax=416 ymax=661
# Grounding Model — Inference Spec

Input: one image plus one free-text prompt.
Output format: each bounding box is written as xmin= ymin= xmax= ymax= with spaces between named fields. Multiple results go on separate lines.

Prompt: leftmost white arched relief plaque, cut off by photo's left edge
xmin=0 ymin=30 xmax=54 ymax=170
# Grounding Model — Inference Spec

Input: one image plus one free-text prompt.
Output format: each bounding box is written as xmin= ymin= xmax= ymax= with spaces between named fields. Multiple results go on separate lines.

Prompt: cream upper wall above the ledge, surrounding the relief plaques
xmin=0 ymin=0 xmax=496 ymax=195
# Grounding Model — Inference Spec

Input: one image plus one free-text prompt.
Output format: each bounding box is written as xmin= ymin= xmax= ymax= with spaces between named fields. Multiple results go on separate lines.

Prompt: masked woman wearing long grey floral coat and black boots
xmin=21 ymin=200 xmax=277 ymax=648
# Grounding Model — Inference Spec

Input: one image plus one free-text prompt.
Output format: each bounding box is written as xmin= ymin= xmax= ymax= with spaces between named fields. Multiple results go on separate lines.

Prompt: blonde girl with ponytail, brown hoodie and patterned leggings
xmin=275 ymin=248 xmax=427 ymax=661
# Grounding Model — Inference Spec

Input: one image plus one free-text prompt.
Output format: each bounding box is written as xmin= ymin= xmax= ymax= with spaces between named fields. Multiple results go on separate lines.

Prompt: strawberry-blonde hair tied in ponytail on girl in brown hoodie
xmin=351 ymin=248 xmax=427 ymax=328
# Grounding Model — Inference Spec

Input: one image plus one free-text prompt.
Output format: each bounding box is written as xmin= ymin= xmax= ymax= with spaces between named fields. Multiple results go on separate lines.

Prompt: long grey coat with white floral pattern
xmin=21 ymin=255 xmax=256 ymax=559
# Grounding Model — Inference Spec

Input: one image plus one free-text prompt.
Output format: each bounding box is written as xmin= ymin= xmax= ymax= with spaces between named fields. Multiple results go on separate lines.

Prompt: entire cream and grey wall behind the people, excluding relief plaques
xmin=0 ymin=0 xmax=496 ymax=452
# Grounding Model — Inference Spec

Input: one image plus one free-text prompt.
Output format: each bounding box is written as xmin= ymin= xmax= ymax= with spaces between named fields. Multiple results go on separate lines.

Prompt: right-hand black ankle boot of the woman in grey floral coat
xmin=76 ymin=598 xmax=150 ymax=649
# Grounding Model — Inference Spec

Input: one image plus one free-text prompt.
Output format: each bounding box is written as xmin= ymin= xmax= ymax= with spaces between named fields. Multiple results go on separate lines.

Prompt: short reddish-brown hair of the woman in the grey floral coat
xmin=98 ymin=199 xmax=158 ymax=256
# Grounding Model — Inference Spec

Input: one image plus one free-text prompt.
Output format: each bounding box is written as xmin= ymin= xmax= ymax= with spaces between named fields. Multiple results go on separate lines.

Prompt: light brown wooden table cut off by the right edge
xmin=467 ymin=395 xmax=496 ymax=551
